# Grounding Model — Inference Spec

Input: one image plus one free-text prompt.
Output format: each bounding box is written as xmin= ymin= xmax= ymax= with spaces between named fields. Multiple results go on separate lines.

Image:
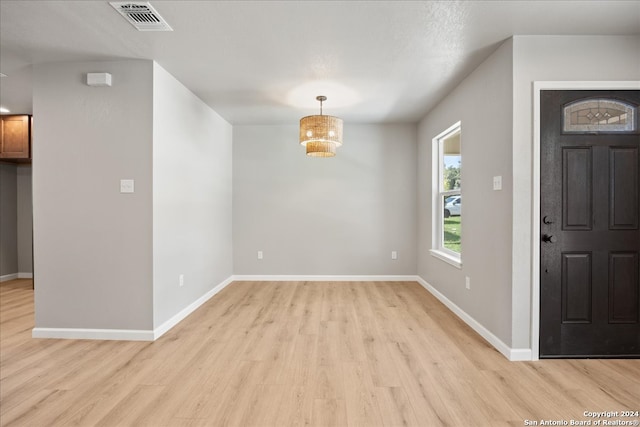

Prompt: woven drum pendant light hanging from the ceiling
xmin=300 ymin=95 xmax=342 ymax=157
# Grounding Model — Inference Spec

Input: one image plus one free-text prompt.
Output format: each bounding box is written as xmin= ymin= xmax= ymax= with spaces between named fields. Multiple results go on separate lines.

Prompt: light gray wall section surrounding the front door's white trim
xmin=512 ymin=36 xmax=640 ymax=347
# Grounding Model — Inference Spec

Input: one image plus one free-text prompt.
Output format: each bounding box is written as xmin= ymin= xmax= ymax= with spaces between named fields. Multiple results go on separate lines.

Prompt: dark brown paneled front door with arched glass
xmin=540 ymin=91 xmax=640 ymax=358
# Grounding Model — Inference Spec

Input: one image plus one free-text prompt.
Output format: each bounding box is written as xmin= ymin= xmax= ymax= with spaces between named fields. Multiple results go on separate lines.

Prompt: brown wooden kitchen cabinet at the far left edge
xmin=0 ymin=114 xmax=32 ymax=163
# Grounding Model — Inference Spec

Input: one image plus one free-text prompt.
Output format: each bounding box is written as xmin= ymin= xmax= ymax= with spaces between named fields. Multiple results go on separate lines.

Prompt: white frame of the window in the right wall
xmin=430 ymin=121 xmax=462 ymax=268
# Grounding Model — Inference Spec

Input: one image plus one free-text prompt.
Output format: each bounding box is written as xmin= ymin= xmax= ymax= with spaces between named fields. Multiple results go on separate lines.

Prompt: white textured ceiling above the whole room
xmin=0 ymin=0 xmax=640 ymax=124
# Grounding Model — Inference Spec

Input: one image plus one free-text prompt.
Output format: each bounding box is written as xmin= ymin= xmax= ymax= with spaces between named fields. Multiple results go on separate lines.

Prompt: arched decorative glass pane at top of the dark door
xmin=563 ymin=98 xmax=638 ymax=133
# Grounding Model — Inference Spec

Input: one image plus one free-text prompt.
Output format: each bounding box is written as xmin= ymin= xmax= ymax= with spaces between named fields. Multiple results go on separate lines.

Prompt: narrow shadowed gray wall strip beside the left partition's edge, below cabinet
xmin=16 ymin=165 xmax=33 ymax=274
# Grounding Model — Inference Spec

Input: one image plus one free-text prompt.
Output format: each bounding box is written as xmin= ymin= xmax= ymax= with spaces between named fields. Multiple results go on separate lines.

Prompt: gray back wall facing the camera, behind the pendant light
xmin=233 ymin=123 xmax=417 ymax=275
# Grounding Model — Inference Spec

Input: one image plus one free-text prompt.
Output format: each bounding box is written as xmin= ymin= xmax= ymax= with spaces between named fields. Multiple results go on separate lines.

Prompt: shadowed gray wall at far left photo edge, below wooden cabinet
xmin=0 ymin=163 xmax=18 ymax=276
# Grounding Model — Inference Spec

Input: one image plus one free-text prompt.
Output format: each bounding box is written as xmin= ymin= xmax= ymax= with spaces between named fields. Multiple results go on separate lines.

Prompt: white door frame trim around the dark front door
xmin=530 ymin=81 xmax=640 ymax=360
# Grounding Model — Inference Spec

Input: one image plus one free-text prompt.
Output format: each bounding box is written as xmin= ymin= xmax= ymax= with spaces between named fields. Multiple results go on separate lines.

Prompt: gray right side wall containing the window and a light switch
xmin=417 ymin=39 xmax=513 ymax=346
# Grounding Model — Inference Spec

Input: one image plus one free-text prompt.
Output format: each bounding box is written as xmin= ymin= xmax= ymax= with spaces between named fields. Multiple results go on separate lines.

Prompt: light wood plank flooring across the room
xmin=0 ymin=280 xmax=640 ymax=427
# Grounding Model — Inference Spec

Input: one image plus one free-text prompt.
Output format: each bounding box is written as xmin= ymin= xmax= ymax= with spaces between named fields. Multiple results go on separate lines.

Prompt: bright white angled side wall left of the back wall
xmin=153 ymin=63 xmax=233 ymax=328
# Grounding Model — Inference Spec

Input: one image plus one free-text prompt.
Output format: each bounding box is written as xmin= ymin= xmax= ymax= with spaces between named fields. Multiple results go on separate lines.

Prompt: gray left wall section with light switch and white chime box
xmin=33 ymin=60 xmax=153 ymax=330
